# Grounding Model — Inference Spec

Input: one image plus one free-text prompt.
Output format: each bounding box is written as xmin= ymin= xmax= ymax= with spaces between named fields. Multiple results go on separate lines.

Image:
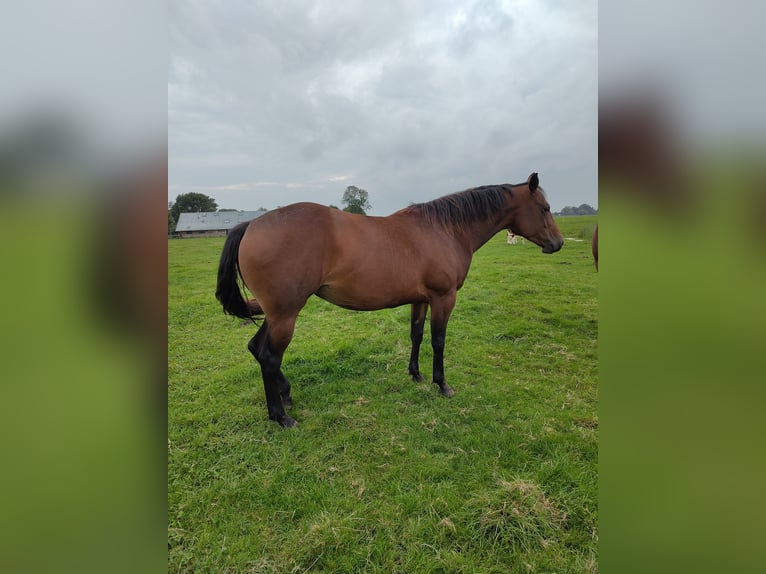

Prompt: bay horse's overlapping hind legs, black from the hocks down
xmin=252 ymin=317 xmax=298 ymax=427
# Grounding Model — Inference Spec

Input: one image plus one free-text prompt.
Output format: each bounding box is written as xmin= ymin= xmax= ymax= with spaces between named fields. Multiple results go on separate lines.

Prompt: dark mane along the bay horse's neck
xmin=402 ymin=184 xmax=513 ymax=228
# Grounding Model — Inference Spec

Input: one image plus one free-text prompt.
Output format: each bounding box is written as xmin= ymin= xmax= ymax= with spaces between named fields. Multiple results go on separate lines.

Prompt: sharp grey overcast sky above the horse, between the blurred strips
xmin=168 ymin=0 xmax=598 ymax=215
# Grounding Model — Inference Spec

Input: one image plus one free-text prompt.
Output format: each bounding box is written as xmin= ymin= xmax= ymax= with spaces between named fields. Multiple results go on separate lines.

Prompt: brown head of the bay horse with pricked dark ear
xmin=508 ymin=172 xmax=564 ymax=253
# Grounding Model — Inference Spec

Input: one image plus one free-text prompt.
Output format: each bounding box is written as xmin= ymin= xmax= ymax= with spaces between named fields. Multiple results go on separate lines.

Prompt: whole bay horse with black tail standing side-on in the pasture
xmin=216 ymin=173 xmax=564 ymax=427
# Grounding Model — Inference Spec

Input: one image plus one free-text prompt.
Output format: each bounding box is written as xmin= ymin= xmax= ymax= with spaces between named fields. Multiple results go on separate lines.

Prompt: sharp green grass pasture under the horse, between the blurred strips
xmin=168 ymin=217 xmax=598 ymax=573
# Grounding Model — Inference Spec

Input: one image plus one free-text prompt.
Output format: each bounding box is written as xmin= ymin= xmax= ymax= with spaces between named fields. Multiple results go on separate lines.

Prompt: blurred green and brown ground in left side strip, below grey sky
xmin=0 ymin=164 xmax=167 ymax=572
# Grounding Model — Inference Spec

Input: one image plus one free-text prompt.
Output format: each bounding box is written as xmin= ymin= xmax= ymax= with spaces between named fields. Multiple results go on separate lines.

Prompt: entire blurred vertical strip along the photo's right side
xmin=599 ymin=2 xmax=766 ymax=573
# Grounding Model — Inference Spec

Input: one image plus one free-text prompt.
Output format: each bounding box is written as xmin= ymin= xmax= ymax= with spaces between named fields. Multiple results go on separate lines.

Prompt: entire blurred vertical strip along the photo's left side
xmin=0 ymin=0 xmax=167 ymax=574
